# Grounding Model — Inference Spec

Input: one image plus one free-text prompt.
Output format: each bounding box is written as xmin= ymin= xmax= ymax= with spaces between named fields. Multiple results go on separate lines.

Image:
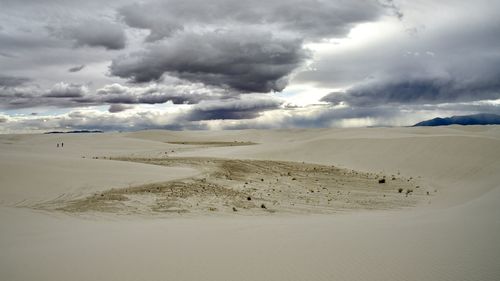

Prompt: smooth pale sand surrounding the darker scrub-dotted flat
xmin=0 ymin=126 xmax=500 ymax=281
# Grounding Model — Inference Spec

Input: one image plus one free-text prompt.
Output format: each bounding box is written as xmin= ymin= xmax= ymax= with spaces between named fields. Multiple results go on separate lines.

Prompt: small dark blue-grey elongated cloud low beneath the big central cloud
xmin=186 ymin=98 xmax=282 ymax=121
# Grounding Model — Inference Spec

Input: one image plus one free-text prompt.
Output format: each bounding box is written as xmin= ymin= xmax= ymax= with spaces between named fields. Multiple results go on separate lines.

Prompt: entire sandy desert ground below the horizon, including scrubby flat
xmin=0 ymin=126 xmax=500 ymax=281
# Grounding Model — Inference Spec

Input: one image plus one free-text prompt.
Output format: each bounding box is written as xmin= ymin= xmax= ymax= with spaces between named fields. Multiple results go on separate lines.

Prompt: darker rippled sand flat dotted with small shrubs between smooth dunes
xmin=32 ymin=157 xmax=430 ymax=215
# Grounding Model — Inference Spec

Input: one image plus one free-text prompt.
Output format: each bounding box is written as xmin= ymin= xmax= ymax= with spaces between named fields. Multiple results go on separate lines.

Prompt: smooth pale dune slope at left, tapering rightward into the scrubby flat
xmin=0 ymin=134 xmax=198 ymax=205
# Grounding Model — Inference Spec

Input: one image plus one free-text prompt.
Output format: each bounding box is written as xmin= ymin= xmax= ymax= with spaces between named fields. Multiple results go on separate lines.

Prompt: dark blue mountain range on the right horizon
xmin=413 ymin=113 xmax=500 ymax=127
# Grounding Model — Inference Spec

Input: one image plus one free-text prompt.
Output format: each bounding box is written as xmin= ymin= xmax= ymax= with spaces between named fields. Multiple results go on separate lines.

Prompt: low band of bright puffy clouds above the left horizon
xmin=0 ymin=78 xmax=229 ymax=110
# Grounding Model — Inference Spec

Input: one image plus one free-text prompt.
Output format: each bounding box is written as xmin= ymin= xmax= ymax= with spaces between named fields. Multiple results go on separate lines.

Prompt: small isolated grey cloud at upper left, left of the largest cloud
xmin=53 ymin=20 xmax=126 ymax=50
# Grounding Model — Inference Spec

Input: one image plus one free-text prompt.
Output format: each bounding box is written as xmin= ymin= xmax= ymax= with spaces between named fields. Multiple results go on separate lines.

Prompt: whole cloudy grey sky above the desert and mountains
xmin=0 ymin=0 xmax=500 ymax=133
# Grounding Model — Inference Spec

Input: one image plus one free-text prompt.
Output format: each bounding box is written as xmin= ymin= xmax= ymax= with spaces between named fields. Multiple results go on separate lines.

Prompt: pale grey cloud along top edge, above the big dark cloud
xmin=119 ymin=0 xmax=384 ymax=42
